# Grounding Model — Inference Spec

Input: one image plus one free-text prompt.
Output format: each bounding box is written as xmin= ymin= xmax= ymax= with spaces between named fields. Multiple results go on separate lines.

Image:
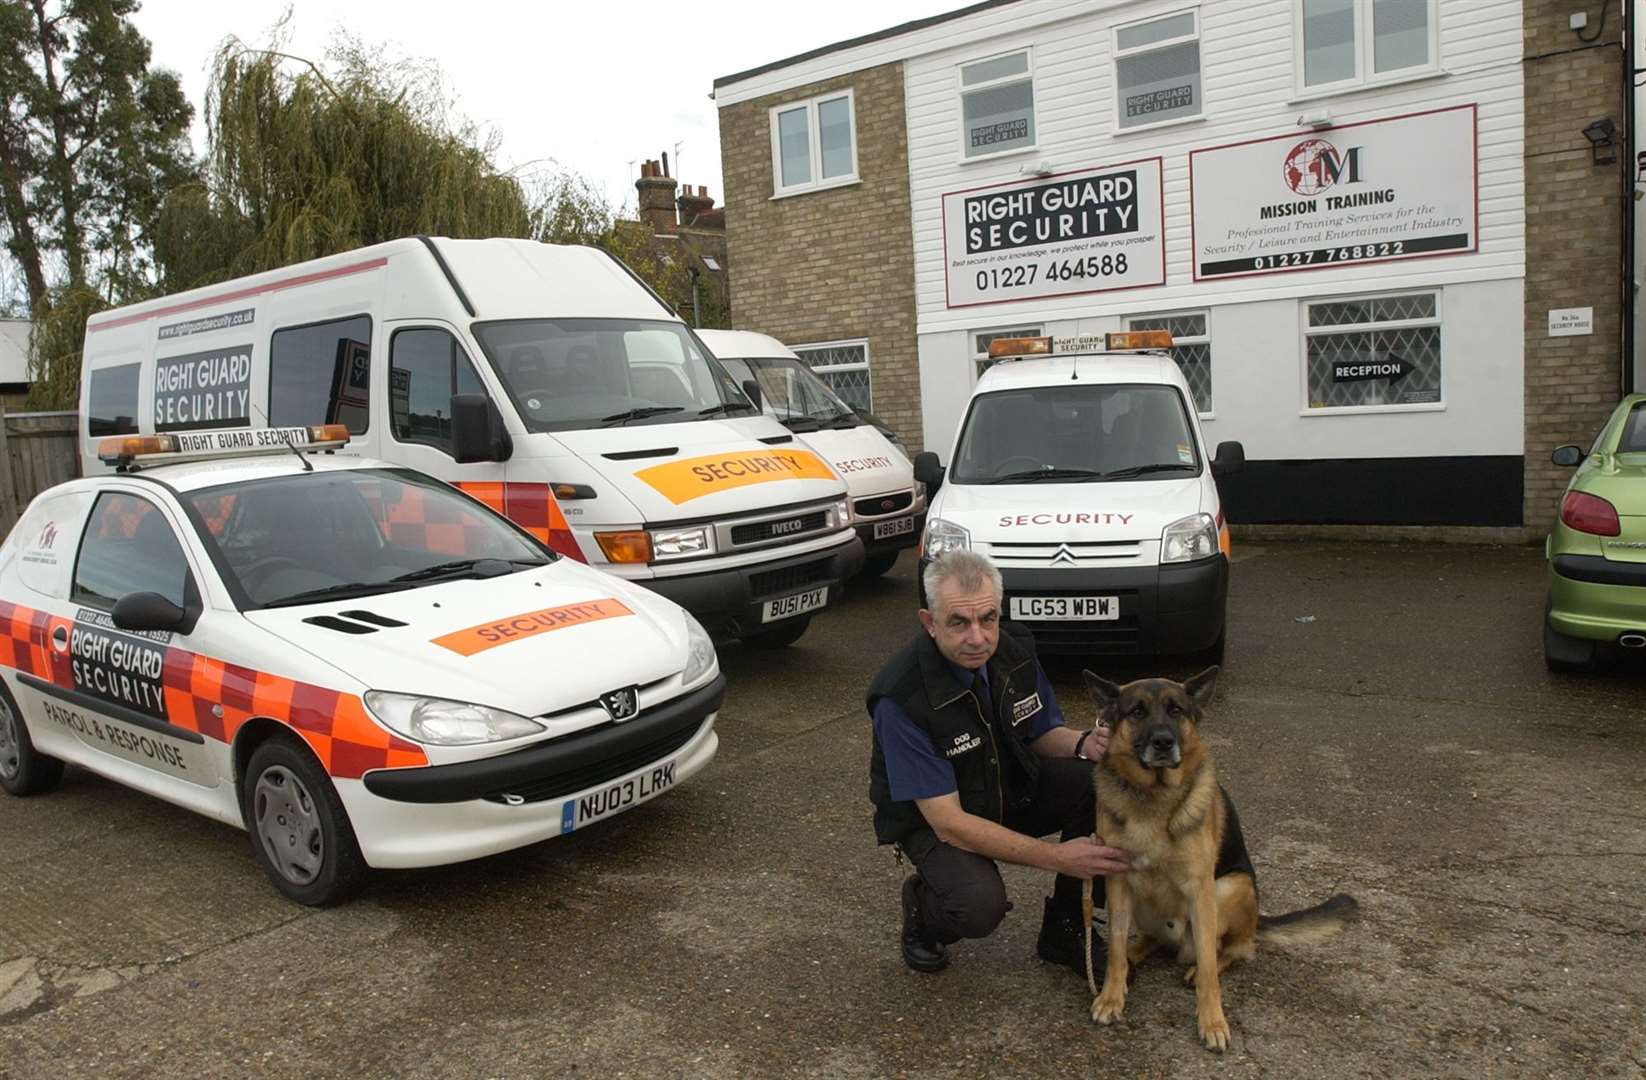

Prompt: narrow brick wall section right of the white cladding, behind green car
xmin=1523 ymin=0 xmax=1628 ymax=537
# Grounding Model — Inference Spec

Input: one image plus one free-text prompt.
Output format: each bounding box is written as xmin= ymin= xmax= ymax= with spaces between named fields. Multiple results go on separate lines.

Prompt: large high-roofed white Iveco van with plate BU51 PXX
xmin=81 ymin=237 xmax=863 ymax=644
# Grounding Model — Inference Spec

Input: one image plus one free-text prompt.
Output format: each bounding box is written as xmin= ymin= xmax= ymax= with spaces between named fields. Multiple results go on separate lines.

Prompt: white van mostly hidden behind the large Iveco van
xmin=698 ymin=329 xmax=925 ymax=576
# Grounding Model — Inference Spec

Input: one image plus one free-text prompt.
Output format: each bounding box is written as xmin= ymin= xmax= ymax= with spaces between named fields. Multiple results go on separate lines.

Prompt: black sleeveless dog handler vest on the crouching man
xmin=866 ymin=622 xmax=1049 ymax=843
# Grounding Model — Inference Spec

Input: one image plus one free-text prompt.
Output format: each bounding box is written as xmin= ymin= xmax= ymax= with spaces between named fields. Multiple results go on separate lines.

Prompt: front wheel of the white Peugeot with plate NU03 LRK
xmin=240 ymin=736 xmax=370 ymax=907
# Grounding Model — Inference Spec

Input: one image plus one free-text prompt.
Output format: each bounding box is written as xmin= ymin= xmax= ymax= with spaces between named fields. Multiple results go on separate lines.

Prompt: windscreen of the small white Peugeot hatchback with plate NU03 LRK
xmin=184 ymin=469 xmax=558 ymax=608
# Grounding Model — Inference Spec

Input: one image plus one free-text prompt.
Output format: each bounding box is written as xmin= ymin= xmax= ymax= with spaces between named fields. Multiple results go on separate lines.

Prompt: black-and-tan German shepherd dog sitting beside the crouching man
xmin=1083 ymin=667 xmax=1358 ymax=1052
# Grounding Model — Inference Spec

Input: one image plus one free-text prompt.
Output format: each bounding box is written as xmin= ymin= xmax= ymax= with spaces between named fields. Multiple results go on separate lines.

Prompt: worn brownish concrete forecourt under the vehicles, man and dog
xmin=0 ymin=543 xmax=1646 ymax=1078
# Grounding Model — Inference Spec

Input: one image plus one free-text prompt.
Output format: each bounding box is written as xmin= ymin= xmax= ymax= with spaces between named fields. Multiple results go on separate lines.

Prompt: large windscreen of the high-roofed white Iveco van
xmin=474 ymin=319 xmax=754 ymax=431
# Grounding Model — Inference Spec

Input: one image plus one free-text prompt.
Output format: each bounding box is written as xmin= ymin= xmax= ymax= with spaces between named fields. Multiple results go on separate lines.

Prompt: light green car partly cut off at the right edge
xmin=1544 ymin=393 xmax=1646 ymax=672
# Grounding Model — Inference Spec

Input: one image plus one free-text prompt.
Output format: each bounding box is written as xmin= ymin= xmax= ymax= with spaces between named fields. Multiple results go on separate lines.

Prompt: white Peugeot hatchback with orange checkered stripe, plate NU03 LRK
xmin=0 ymin=425 xmax=726 ymax=905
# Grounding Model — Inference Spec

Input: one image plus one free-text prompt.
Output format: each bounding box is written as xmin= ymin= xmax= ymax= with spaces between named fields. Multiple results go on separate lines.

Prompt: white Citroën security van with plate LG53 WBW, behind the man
xmin=915 ymin=331 xmax=1246 ymax=662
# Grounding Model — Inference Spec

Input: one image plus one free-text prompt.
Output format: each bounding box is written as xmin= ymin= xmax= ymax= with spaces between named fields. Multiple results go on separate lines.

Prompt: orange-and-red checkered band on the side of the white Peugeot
xmin=0 ymin=603 xmax=428 ymax=780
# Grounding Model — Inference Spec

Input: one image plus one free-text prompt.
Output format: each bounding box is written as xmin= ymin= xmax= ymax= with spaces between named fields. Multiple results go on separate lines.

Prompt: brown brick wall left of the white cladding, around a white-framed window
xmin=719 ymin=64 xmax=923 ymax=449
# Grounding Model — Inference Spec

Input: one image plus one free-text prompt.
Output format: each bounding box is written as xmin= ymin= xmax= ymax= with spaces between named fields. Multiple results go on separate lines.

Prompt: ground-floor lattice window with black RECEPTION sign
xmin=1304 ymin=291 xmax=1442 ymax=408
